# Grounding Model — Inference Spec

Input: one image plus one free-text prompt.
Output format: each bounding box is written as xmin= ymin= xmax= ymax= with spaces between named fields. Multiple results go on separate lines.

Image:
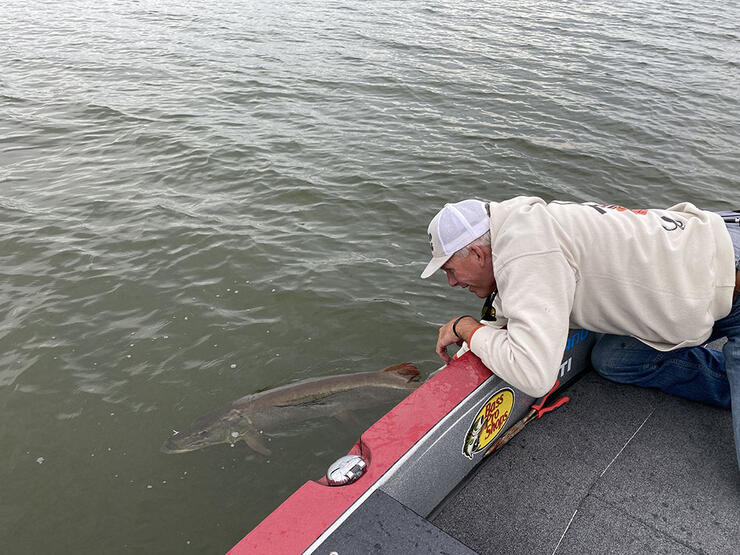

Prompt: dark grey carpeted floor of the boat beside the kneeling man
xmin=428 ymin=372 xmax=740 ymax=554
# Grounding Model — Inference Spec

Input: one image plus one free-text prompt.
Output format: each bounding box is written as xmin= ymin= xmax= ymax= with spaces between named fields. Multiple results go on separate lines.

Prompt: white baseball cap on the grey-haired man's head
xmin=421 ymin=199 xmax=490 ymax=279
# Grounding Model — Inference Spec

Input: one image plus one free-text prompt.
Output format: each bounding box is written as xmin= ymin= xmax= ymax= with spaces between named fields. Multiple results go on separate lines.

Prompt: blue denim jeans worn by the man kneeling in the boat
xmin=591 ymin=217 xmax=740 ymax=468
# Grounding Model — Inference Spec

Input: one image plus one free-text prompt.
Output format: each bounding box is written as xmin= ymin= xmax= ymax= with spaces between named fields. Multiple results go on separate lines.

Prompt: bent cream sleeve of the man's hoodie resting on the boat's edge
xmin=470 ymin=250 xmax=576 ymax=397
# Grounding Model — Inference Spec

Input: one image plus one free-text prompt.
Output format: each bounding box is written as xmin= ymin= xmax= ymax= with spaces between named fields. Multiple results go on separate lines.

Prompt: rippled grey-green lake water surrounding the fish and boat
xmin=0 ymin=0 xmax=740 ymax=553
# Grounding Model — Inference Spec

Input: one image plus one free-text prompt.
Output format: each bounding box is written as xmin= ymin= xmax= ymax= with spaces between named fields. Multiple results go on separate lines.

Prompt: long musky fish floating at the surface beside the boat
xmin=162 ymin=363 xmax=419 ymax=455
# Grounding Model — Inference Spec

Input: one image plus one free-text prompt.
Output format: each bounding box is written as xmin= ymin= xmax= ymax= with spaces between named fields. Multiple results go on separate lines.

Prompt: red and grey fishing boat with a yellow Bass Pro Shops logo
xmin=229 ymin=330 xmax=740 ymax=555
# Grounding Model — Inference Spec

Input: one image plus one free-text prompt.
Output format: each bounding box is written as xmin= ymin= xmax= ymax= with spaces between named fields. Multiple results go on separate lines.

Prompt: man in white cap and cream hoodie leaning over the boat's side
xmin=421 ymin=197 xmax=740 ymax=461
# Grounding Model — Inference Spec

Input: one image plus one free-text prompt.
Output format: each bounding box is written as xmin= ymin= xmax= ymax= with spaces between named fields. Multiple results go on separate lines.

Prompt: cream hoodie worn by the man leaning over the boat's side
xmin=470 ymin=197 xmax=735 ymax=397
